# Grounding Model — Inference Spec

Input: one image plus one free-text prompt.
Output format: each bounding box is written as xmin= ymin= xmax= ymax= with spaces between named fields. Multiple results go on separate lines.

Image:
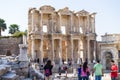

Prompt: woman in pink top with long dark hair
xmin=81 ymin=62 xmax=90 ymax=80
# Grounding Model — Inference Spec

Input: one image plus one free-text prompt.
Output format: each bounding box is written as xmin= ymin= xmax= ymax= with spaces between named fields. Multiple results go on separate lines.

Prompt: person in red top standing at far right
xmin=111 ymin=60 xmax=118 ymax=80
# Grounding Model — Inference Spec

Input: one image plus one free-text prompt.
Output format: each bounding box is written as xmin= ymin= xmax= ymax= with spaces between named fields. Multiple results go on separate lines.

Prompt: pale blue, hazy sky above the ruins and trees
xmin=0 ymin=0 xmax=120 ymax=40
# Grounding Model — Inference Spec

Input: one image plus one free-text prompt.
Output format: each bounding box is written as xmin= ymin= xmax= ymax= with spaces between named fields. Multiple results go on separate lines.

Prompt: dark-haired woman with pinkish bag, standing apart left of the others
xmin=44 ymin=60 xmax=53 ymax=80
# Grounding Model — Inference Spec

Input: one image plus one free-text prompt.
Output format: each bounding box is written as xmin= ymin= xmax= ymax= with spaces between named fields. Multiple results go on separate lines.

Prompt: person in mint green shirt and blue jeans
xmin=92 ymin=60 xmax=103 ymax=80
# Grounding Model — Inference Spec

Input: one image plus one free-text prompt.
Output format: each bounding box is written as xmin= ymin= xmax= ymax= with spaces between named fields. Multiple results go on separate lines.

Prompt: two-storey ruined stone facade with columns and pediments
xmin=28 ymin=5 xmax=96 ymax=64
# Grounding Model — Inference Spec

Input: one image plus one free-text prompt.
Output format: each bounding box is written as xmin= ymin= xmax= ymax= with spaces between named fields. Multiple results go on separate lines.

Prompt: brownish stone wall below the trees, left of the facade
xmin=0 ymin=37 xmax=23 ymax=55
